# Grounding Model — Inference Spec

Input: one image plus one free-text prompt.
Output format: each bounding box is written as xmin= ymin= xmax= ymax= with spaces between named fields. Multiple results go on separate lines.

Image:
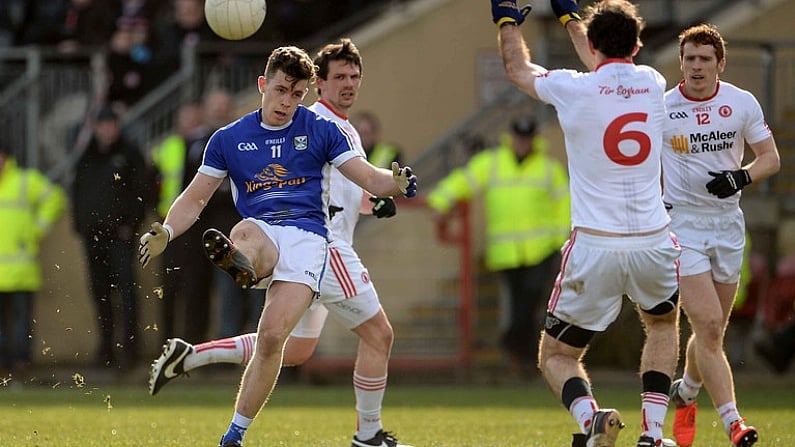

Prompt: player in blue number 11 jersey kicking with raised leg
xmin=139 ymin=47 xmax=416 ymax=447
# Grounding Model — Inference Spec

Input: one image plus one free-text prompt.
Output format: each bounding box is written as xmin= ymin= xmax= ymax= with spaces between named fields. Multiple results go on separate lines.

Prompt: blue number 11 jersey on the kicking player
xmin=199 ymin=105 xmax=359 ymax=238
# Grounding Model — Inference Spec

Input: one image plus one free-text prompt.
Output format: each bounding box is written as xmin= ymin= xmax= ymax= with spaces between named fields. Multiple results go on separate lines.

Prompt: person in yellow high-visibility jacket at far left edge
xmin=0 ymin=142 xmax=66 ymax=373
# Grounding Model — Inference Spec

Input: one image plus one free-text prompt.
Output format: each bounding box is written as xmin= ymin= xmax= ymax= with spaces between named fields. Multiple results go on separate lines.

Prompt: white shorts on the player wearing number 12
xmin=668 ymin=205 xmax=745 ymax=284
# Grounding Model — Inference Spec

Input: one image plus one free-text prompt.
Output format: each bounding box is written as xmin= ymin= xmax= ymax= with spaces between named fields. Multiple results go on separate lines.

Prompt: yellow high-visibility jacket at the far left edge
xmin=0 ymin=158 xmax=66 ymax=292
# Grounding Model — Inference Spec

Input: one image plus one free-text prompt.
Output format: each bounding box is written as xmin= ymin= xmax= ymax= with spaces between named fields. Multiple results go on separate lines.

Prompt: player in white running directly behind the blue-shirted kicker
xmin=149 ymin=39 xmax=414 ymax=447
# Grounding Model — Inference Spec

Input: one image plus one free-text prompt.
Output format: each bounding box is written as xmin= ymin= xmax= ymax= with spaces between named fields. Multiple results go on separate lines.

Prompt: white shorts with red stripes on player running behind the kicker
xmin=291 ymin=241 xmax=381 ymax=338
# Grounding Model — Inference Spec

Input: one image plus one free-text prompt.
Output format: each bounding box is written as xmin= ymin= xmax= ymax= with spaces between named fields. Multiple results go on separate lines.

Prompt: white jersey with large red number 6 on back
xmin=535 ymin=59 xmax=668 ymax=234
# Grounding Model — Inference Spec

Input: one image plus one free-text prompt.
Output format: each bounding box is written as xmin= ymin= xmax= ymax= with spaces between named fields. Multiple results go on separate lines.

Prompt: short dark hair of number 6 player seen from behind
xmin=584 ymin=0 xmax=646 ymax=58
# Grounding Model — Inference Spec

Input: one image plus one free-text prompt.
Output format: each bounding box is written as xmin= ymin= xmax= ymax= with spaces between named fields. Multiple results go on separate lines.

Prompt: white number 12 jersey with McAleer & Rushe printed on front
xmin=662 ymin=81 xmax=772 ymax=208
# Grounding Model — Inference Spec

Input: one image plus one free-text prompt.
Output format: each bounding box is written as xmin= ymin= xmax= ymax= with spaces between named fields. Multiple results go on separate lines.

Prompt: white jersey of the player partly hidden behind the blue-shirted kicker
xmin=309 ymin=100 xmax=367 ymax=245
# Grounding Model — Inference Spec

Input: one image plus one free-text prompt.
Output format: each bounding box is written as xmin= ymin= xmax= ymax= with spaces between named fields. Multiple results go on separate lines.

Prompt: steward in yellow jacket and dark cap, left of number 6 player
xmin=427 ymin=117 xmax=570 ymax=375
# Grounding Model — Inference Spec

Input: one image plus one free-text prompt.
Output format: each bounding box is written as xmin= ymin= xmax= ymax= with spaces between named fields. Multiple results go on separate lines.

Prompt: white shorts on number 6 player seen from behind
xmin=548 ymin=229 xmax=680 ymax=332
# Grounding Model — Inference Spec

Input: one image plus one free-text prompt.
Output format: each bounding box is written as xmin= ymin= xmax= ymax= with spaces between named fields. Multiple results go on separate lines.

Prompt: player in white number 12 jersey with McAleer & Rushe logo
xmin=662 ymin=24 xmax=779 ymax=447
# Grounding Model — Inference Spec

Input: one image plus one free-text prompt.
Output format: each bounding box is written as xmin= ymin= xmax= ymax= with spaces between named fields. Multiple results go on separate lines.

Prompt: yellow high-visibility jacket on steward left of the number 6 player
xmin=427 ymin=137 xmax=571 ymax=271
